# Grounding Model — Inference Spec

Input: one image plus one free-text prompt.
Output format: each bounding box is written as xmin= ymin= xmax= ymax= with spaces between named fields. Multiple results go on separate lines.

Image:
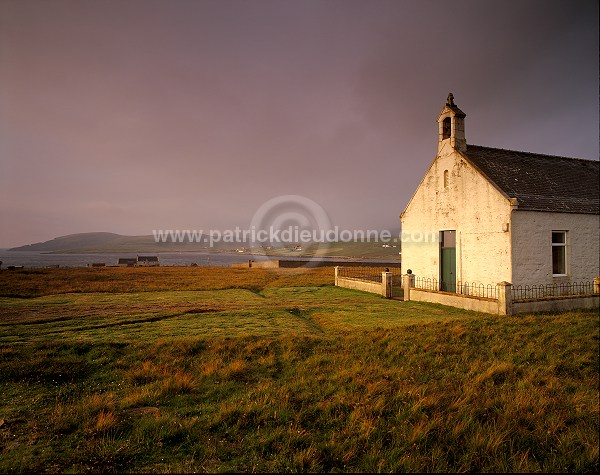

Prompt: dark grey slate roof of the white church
xmin=464 ymin=145 xmax=600 ymax=214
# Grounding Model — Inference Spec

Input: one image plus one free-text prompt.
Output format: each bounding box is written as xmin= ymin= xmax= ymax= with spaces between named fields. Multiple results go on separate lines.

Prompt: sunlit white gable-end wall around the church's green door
xmin=401 ymin=145 xmax=512 ymax=285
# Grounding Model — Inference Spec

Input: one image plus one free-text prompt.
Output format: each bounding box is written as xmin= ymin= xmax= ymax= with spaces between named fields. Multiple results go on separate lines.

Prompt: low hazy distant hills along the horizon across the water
xmin=9 ymin=232 xmax=400 ymax=259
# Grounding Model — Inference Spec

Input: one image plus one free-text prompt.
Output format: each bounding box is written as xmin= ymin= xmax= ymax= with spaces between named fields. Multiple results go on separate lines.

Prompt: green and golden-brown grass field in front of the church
xmin=0 ymin=268 xmax=599 ymax=473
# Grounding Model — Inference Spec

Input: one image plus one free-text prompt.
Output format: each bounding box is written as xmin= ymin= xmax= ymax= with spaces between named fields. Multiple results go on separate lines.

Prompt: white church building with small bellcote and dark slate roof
xmin=400 ymin=94 xmax=600 ymax=292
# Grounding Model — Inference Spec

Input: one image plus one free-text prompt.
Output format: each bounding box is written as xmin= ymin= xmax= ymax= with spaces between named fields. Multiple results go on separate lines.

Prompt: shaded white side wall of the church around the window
xmin=510 ymin=210 xmax=600 ymax=285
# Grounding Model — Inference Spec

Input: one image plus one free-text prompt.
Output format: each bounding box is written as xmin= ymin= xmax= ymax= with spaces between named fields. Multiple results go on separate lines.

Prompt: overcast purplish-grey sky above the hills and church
xmin=0 ymin=0 xmax=599 ymax=247
